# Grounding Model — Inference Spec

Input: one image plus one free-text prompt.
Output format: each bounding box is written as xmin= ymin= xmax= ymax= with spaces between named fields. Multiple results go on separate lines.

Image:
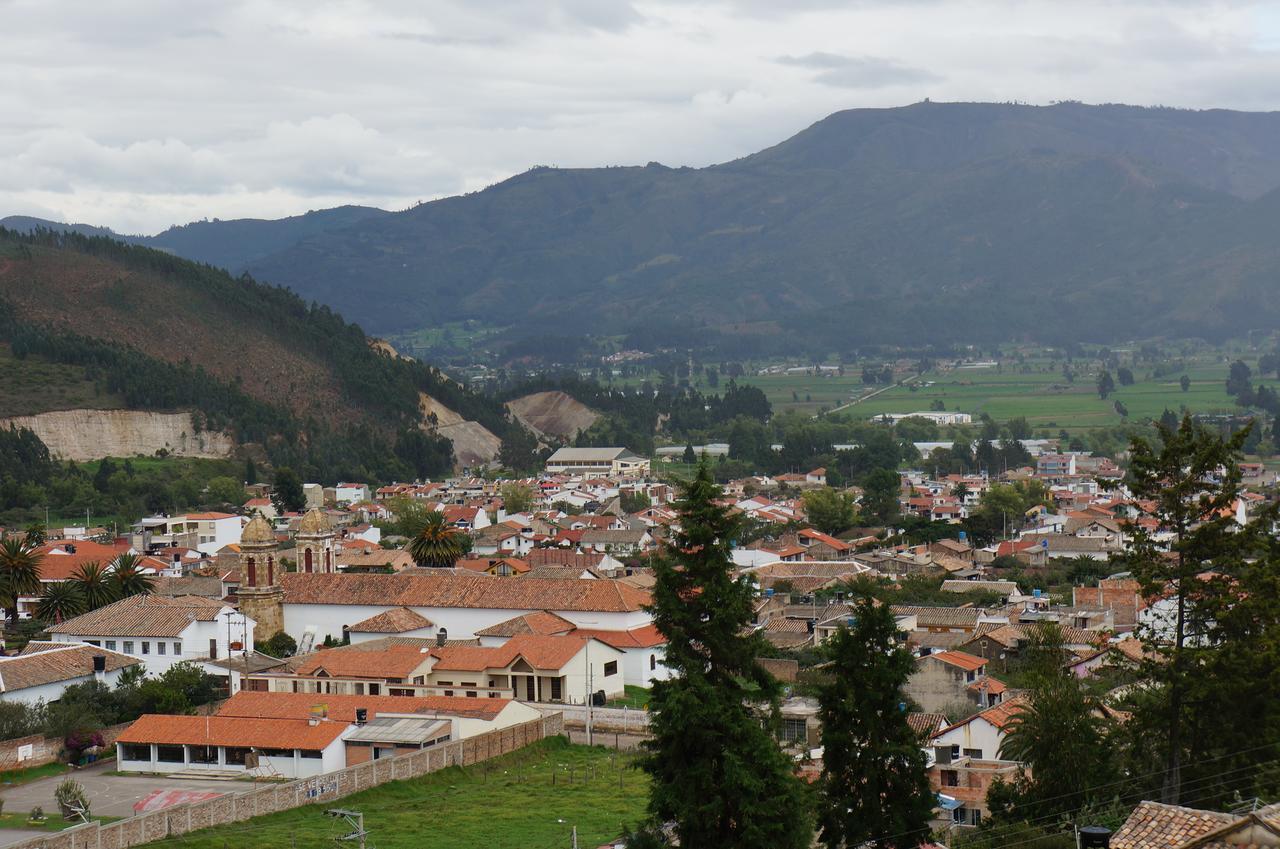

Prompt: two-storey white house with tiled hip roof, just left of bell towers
xmin=49 ymin=595 xmax=255 ymax=675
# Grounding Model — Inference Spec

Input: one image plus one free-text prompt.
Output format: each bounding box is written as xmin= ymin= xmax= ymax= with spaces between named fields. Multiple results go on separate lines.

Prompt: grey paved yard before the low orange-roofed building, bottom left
xmin=0 ymin=761 xmax=240 ymax=824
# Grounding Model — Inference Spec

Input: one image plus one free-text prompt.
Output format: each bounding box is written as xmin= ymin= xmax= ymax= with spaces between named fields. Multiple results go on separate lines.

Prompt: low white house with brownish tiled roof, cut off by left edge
xmin=0 ymin=642 xmax=140 ymax=704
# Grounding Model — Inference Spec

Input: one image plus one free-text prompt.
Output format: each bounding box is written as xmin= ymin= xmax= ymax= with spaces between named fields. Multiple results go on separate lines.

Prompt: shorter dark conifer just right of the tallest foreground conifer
xmin=818 ymin=598 xmax=934 ymax=849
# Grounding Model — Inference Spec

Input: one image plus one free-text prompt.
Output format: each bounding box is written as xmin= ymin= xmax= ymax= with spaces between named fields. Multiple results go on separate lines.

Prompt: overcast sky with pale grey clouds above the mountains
xmin=0 ymin=0 xmax=1280 ymax=233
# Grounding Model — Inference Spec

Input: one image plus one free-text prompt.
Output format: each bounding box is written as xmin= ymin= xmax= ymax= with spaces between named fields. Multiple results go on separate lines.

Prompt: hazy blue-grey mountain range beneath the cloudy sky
xmin=0 ymin=102 xmax=1280 ymax=351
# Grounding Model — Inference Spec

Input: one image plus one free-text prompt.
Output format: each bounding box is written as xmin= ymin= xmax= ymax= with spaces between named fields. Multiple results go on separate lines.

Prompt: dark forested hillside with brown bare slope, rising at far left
xmin=0 ymin=230 xmax=516 ymax=480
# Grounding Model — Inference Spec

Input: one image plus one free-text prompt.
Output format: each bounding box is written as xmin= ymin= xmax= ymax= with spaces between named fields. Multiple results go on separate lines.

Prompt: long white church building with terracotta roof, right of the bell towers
xmin=279 ymin=572 xmax=653 ymax=642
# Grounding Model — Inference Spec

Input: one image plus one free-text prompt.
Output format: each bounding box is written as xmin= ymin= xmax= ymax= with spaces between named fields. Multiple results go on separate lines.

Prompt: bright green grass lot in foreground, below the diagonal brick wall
xmin=137 ymin=738 xmax=648 ymax=849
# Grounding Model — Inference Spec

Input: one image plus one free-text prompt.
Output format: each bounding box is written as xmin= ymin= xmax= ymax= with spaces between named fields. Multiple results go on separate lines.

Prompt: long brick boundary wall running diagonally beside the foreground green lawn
xmin=9 ymin=713 xmax=564 ymax=849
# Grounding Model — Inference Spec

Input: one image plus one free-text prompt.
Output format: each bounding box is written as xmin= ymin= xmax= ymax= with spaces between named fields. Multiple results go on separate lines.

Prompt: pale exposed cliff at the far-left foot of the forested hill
xmin=0 ymin=410 xmax=236 ymax=460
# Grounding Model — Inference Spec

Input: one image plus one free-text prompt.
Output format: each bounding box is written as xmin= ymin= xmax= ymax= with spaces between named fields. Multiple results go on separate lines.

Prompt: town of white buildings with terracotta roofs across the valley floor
xmin=0 ymin=441 xmax=1274 ymax=845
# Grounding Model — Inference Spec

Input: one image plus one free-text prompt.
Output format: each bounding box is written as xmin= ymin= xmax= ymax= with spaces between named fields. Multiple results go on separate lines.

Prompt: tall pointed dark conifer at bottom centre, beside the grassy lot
xmin=641 ymin=460 xmax=813 ymax=849
